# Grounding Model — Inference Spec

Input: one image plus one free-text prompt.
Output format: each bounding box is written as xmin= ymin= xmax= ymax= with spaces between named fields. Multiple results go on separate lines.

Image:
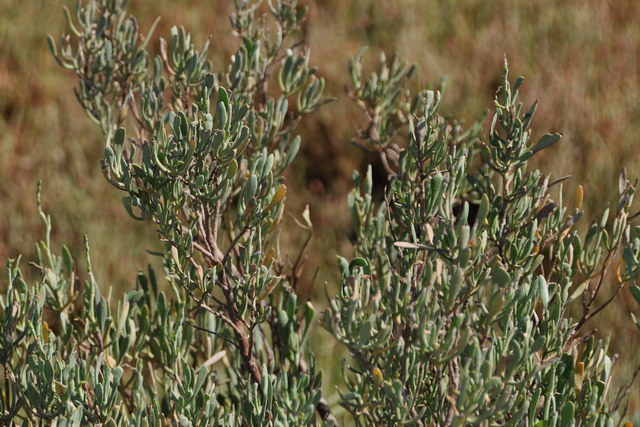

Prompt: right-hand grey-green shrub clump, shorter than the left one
xmin=323 ymin=57 xmax=640 ymax=426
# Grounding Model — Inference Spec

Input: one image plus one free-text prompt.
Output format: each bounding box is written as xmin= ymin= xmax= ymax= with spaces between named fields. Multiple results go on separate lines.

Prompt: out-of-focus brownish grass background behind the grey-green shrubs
xmin=0 ymin=0 xmax=640 ymax=409
